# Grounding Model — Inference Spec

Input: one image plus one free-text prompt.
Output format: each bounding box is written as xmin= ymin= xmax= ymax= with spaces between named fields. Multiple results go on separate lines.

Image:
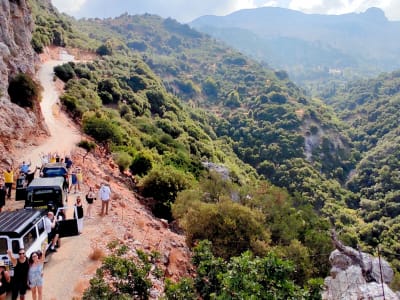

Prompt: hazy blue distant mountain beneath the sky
xmin=190 ymin=7 xmax=400 ymax=92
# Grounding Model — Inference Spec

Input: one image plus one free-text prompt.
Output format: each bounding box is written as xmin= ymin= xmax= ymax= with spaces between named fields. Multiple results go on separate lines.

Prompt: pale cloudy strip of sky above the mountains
xmin=52 ymin=0 xmax=400 ymax=23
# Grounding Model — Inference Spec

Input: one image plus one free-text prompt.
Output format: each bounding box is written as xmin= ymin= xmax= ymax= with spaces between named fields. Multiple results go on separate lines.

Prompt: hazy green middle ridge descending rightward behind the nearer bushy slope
xmin=74 ymin=15 xmax=352 ymax=195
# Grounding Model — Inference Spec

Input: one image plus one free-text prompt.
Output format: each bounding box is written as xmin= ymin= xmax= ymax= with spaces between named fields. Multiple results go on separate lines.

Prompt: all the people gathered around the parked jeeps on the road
xmin=0 ymin=153 xmax=111 ymax=300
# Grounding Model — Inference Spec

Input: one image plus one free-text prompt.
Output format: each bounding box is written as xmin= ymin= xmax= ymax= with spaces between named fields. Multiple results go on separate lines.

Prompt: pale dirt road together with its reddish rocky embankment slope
xmin=6 ymin=50 xmax=191 ymax=300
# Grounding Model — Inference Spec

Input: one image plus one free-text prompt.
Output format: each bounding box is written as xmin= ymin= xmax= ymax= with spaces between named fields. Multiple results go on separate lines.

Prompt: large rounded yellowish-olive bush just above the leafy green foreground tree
xmin=174 ymin=199 xmax=269 ymax=258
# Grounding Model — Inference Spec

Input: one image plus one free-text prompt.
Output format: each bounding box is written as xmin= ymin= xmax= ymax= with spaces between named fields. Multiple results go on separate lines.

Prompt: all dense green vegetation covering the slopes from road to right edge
xmin=29 ymin=0 xmax=400 ymax=299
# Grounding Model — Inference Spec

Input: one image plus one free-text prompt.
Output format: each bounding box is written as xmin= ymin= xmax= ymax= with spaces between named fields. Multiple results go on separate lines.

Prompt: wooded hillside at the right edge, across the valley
xmin=326 ymin=71 xmax=400 ymax=272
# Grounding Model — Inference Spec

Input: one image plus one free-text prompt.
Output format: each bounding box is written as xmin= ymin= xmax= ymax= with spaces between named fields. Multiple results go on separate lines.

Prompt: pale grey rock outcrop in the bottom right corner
xmin=322 ymin=232 xmax=400 ymax=300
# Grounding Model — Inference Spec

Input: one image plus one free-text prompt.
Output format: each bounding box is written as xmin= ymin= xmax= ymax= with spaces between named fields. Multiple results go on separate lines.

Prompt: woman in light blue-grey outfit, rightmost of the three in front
xmin=28 ymin=251 xmax=45 ymax=300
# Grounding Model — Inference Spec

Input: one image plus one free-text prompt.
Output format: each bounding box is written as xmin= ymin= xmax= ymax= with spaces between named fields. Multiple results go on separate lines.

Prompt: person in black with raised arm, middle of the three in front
xmin=7 ymin=248 xmax=29 ymax=300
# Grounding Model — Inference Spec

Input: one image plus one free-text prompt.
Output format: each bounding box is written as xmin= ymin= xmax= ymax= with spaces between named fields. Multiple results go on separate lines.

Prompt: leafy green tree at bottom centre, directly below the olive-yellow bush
xmin=188 ymin=241 xmax=309 ymax=300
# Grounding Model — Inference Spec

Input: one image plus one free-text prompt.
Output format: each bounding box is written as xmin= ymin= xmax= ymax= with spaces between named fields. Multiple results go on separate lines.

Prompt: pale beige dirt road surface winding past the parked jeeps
xmin=15 ymin=55 xmax=101 ymax=300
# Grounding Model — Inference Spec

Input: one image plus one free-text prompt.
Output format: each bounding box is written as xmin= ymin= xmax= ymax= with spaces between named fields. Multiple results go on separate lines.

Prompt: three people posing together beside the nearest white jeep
xmin=0 ymin=249 xmax=45 ymax=300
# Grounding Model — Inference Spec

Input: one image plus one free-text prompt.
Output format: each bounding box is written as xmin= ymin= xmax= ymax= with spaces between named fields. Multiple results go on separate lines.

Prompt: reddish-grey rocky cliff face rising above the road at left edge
xmin=0 ymin=0 xmax=47 ymax=165
